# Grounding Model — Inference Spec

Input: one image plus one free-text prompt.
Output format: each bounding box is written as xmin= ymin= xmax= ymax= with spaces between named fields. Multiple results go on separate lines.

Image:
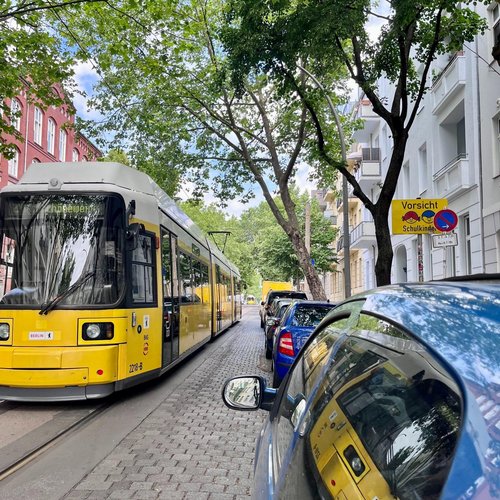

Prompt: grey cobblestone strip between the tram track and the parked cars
xmin=64 ymin=307 xmax=270 ymax=500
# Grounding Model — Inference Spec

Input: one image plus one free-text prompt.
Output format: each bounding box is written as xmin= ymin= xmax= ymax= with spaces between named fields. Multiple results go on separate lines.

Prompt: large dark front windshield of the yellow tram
xmin=0 ymin=194 xmax=125 ymax=313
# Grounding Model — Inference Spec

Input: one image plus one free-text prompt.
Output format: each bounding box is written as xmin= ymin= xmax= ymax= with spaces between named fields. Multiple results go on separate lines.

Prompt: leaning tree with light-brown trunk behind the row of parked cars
xmin=50 ymin=0 xmax=340 ymax=299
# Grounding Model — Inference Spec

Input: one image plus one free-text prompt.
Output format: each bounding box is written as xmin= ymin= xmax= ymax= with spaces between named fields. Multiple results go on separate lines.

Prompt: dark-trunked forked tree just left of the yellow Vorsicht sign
xmin=223 ymin=0 xmax=486 ymax=285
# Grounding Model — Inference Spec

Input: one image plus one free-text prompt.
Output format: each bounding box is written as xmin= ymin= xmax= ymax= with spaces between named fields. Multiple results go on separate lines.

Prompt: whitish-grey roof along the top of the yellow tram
xmin=3 ymin=162 xmax=238 ymax=272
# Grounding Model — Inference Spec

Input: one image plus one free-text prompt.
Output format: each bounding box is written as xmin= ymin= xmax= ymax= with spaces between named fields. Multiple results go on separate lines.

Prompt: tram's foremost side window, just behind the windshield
xmin=132 ymin=234 xmax=155 ymax=303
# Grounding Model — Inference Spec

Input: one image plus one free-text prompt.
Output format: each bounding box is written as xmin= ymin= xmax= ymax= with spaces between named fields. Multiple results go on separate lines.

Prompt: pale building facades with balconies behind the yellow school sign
xmin=325 ymin=1 xmax=500 ymax=300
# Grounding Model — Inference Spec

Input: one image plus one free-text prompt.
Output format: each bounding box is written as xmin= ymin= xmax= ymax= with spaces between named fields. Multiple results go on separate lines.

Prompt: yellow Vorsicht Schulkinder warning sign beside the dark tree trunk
xmin=392 ymin=198 xmax=448 ymax=234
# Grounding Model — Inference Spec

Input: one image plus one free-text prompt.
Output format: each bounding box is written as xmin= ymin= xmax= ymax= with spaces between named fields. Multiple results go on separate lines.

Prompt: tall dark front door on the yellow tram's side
xmin=161 ymin=228 xmax=179 ymax=366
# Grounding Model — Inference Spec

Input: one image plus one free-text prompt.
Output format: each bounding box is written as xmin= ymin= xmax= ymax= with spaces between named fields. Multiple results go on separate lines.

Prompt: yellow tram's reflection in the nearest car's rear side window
xmin=307 ymin=322 xmax=461 ymax=499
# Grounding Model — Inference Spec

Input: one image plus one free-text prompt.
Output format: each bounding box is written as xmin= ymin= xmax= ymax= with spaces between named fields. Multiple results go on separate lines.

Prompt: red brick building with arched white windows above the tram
xmin=0 ymin=86 xmax=102 ymax=188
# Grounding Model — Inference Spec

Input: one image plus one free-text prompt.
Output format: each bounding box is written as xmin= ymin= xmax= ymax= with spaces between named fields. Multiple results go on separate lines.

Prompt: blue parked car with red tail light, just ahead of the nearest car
xmin=271 ymin=300 xmax=335 ymax=387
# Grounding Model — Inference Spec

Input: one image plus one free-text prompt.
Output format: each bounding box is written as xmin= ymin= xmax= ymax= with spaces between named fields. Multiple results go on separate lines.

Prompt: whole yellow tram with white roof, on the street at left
xmin=0 ymin=162 xmax=242 ymax=401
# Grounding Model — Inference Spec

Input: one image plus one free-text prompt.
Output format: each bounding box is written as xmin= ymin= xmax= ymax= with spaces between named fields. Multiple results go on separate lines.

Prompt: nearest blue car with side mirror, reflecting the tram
xmin=223 ymin=276 xmax=500 ymax=500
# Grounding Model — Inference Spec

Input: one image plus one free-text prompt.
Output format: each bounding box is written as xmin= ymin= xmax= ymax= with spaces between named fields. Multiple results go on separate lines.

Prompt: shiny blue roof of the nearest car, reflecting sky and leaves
xmin=344 ymin=280 xmax=500 ymax=392
